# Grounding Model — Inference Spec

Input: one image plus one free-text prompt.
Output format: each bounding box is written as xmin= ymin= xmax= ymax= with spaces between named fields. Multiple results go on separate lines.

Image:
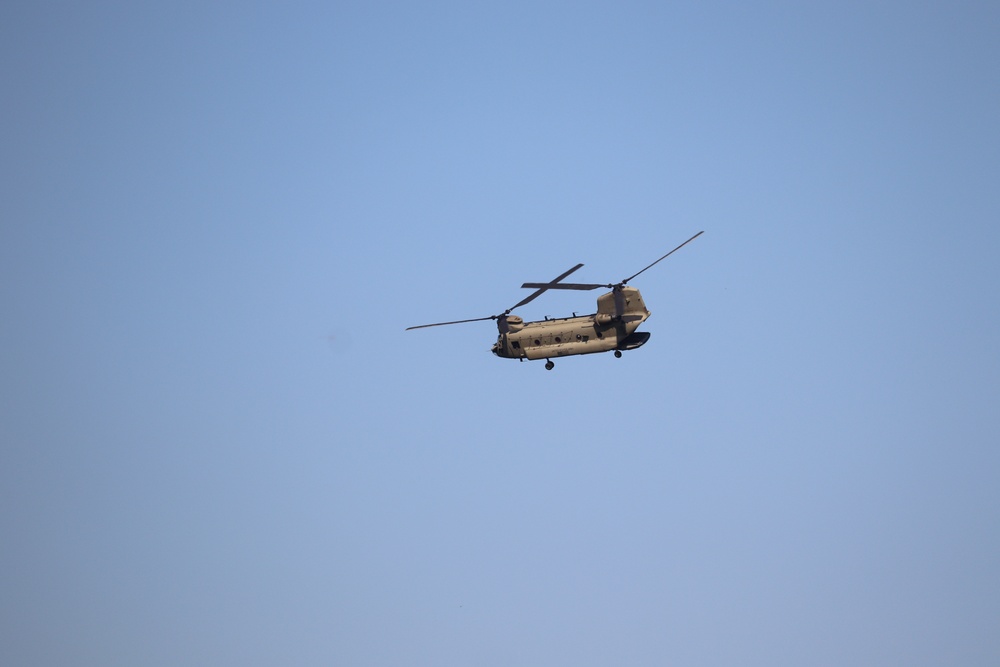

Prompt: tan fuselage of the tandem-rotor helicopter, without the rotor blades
xmin=493 ymin=286 xmax=650 ymax=359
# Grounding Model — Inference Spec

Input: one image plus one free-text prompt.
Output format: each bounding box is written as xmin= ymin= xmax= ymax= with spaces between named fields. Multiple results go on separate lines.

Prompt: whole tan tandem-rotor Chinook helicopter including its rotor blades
xmin=406 ymin=232 xmax=704 ymax=370
